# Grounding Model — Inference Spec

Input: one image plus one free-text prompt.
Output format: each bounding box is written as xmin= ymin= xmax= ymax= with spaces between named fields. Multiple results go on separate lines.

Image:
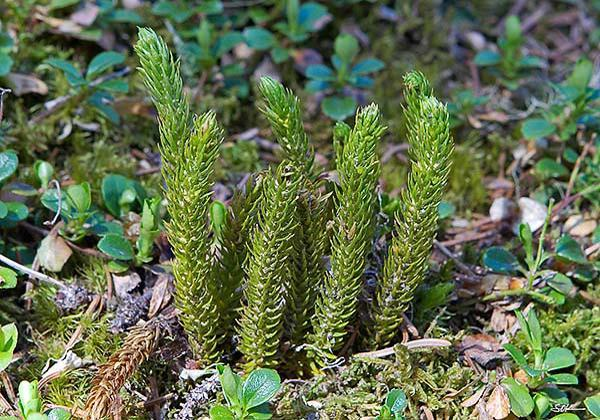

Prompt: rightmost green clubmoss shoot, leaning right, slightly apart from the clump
xmin=371 ymin=72 xmax=453 ymax=346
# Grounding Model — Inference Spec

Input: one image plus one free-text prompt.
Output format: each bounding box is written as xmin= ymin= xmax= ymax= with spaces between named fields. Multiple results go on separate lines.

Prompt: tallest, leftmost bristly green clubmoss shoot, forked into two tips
xmin=135 ymin=29 xmax=223 ymax=363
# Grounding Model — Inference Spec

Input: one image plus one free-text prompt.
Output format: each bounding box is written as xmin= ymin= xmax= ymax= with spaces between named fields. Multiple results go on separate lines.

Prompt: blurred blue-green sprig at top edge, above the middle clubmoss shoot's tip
xmin=244 ymin=0 xmax=327 ymax=63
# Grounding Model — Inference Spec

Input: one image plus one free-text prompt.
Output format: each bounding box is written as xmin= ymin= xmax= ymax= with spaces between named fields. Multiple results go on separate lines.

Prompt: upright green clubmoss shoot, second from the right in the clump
xmin=309 ymin=105 xmax=385 ymax=366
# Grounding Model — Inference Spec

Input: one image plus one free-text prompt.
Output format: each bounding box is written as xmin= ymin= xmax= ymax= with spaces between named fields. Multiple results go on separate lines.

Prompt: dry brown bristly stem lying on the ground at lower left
xmin=85 ymin=322 xmax=161 ymax=420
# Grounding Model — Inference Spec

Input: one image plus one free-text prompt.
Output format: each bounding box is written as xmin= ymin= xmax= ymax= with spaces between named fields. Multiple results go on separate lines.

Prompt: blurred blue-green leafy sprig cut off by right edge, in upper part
xmin=521 ymin=58 xmax=600 ymax=141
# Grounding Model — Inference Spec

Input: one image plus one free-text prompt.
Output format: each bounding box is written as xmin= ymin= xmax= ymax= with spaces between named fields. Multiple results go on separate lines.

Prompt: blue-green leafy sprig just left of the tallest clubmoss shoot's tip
xmin=47 ymin=51 xmax=129 ymax=124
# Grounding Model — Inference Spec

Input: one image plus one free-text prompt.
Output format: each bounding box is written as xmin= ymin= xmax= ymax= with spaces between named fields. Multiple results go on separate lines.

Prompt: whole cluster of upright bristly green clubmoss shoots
xmin=135 ymin=29 xmax=453 ymax=371
